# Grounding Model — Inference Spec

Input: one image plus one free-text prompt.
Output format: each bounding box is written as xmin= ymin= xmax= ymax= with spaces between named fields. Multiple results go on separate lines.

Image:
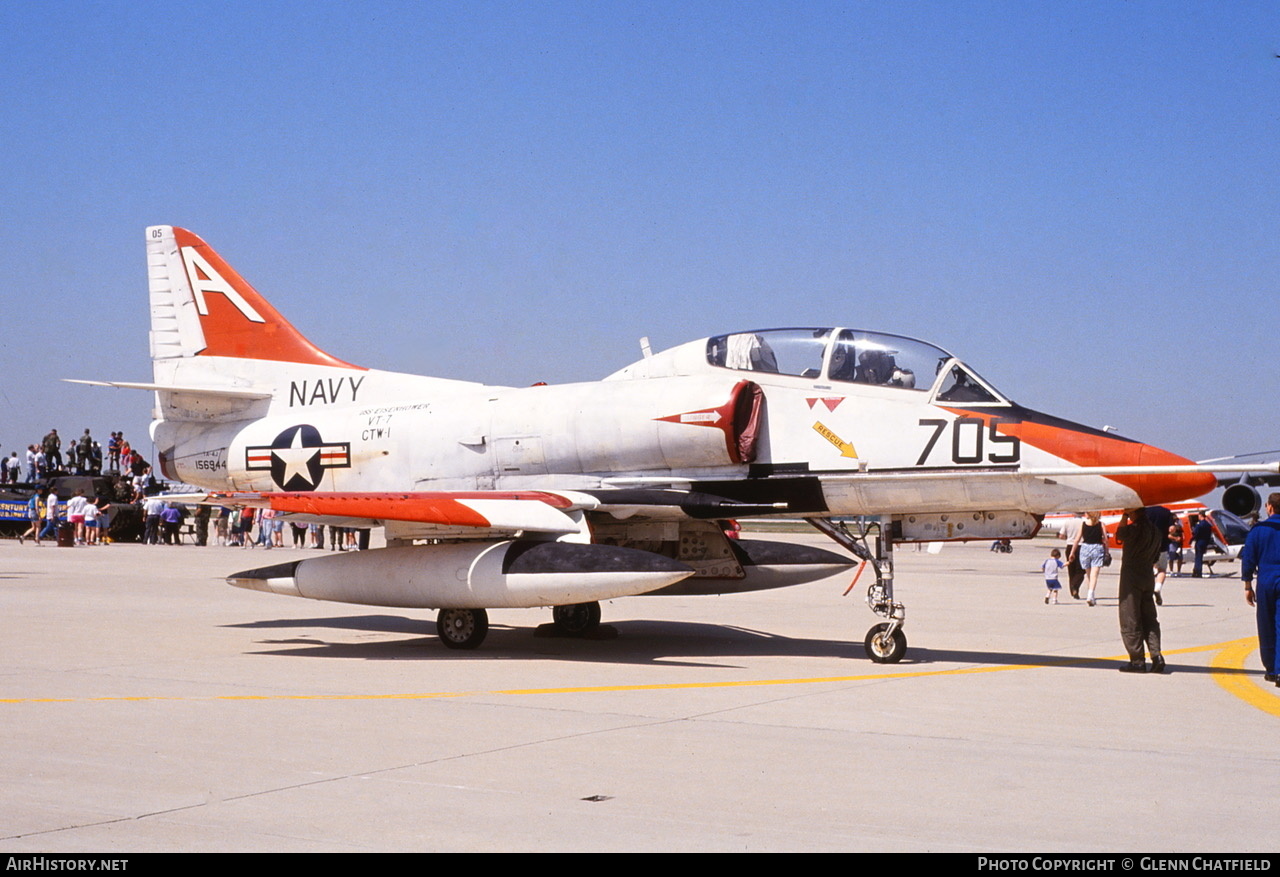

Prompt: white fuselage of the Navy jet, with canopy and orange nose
xmin=154 ymin=329 xmax=1213 ymax=515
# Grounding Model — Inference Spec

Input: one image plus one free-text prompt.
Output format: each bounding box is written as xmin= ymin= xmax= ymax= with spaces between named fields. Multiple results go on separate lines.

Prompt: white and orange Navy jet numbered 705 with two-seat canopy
xmin=74 ymin=225 xmax=1275 ymax=662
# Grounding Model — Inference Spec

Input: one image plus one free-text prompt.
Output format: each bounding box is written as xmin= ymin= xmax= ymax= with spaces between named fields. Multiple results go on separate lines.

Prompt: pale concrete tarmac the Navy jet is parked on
xmin=0 ymin=536 xmax=1280 ymax=853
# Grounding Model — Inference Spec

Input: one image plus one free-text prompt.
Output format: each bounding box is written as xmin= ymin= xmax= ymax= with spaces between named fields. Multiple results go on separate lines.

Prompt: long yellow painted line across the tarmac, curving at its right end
xmin=0 ymin=636 xmax=1280 ymax=716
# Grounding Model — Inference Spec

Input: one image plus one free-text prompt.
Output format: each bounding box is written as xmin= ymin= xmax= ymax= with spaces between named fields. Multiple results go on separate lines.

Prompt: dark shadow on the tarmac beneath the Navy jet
xmin=228 ymin=615 xmax=1261 ymax=675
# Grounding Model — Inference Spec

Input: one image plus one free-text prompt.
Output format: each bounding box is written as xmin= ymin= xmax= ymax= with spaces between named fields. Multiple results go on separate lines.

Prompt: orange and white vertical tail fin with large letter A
xmin=147 ymin=225 xmax=360 ymax=369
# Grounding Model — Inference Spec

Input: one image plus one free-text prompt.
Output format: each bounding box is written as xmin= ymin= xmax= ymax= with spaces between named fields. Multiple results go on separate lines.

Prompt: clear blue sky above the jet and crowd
xmin=0 ymin=0 xmax=1280 ymax=471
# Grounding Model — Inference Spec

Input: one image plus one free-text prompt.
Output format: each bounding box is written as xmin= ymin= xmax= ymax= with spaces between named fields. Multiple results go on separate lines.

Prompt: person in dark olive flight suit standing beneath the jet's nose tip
xmin=1116 ymin=508 xmax=1165 ymax=673
